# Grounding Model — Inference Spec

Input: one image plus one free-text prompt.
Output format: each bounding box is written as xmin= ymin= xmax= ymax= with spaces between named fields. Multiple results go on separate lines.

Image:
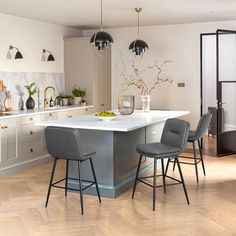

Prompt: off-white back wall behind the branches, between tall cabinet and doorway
xmin=84 ymin=21 xmax=236 ymax=128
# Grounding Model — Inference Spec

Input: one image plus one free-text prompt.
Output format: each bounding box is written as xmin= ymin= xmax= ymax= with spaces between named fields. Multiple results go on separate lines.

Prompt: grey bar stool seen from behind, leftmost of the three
xmin=45 ymin=127 xmax=101 ymax=215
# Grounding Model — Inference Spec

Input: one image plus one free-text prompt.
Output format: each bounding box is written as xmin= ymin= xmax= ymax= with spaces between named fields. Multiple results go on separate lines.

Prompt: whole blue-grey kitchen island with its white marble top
xmin=36 ymin=110 xmax=189 ymax=198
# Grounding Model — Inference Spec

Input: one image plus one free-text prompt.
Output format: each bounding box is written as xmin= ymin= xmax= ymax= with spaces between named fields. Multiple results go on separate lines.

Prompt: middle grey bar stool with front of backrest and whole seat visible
xmin=132 ymin=119 xmax=189 ymax=211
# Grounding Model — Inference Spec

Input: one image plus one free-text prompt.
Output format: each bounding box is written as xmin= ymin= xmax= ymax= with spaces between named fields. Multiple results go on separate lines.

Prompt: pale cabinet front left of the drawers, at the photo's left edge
xmin=0 ymin=120 xmax=19 ymax=165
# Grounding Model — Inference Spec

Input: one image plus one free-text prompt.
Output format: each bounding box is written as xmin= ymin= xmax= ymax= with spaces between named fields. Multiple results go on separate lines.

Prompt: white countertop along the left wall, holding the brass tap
xmin=0 ymin=105 xmax=94 ymax=120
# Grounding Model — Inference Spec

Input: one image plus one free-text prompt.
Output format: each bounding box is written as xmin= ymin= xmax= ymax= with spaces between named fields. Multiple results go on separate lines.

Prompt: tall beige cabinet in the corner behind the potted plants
xmin=64 ymin=37 xmax=111 ymax=112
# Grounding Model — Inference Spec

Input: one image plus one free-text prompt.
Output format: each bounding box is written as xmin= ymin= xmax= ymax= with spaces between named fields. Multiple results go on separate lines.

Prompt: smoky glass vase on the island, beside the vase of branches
xmin=118 ymin=95 xmax=134 ymax=115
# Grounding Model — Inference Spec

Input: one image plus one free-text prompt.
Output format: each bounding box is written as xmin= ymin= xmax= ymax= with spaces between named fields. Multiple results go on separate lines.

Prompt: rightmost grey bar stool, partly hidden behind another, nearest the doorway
xmin=170 ymin=113 xmax=212 ymax=183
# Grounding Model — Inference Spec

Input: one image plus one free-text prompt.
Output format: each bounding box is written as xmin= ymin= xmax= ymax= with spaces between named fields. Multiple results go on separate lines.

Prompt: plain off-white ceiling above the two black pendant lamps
xmin=0 ymin=0 xmax=236 ymax=29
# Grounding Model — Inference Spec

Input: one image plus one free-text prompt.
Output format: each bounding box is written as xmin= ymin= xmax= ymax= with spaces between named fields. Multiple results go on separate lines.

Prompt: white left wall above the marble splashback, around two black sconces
xmin=0 ymin=14 xmax=82 ymax=72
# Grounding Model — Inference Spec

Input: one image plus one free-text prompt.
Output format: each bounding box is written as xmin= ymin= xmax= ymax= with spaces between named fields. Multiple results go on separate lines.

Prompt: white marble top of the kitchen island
xmin=35 ymin=110 xmax=189 ymax=132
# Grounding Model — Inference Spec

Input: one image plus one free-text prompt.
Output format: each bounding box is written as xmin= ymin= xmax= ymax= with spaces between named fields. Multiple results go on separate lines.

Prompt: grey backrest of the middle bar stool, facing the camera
xmin=161 ymin=119 xmax=190 ymax=150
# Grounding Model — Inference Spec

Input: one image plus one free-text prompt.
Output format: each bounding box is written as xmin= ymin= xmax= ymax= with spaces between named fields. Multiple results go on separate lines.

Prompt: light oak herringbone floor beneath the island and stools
xmin=0 ymin=156 xmax=236 ymax=236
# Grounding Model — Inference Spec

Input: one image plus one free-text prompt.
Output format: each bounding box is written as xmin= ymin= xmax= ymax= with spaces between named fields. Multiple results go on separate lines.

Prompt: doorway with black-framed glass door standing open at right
xmin=200 ymin=29 xmax=236 ymax=156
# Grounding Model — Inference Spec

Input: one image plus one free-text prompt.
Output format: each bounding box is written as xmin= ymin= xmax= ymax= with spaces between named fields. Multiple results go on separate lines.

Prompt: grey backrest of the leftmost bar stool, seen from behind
xmin=45 ymin=126 xmax=83 ymax=160
